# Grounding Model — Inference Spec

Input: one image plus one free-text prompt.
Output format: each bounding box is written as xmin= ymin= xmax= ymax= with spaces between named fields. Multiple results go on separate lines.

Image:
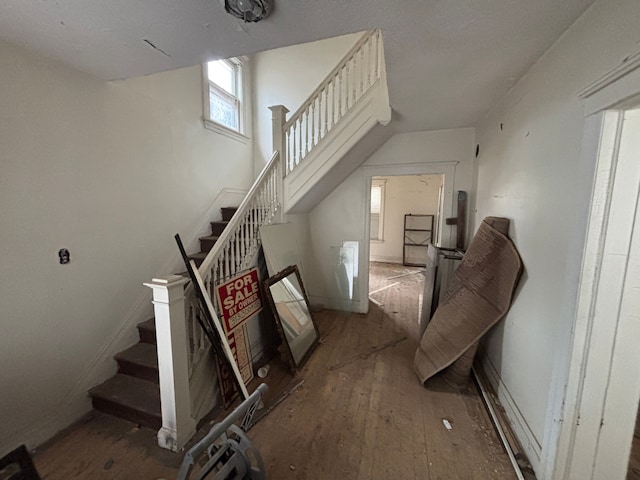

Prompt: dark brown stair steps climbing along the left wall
xmin=89 ymin=207 xmax=237 ymax=430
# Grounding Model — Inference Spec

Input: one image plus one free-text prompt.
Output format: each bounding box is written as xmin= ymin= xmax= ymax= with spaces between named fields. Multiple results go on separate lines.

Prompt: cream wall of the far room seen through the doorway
xmin=369 ymin=175 xmax=443 ymax=263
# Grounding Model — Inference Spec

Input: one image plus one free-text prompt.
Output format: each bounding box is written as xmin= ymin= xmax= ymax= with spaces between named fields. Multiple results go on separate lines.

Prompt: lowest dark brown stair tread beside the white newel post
xmin=89 ymin=373 xmax=161 ymax=417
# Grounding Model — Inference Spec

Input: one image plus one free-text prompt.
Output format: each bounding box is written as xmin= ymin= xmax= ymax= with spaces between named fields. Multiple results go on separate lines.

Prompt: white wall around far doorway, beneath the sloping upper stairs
xmin=309 ymin=128 xmax=475 ymax=312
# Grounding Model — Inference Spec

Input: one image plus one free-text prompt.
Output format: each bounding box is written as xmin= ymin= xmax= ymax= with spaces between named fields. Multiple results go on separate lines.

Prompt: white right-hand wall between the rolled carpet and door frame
xmin=475 ymin=0 xmax=640 ymax=472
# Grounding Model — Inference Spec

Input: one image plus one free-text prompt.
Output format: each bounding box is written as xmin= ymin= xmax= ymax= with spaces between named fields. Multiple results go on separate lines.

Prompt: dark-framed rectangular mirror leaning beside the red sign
xmin=264 ymin=265 xmax=319 ymax=370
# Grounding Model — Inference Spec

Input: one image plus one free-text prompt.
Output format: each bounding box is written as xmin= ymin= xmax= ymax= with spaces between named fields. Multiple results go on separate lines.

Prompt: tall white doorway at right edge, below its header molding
xmin=556 ymin=102 xmax=640 ymax=480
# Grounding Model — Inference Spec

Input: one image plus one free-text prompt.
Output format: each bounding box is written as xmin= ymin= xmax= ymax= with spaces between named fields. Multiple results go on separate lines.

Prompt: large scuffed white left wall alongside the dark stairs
xmin=0 ymin=42 xmax=253 ymax=452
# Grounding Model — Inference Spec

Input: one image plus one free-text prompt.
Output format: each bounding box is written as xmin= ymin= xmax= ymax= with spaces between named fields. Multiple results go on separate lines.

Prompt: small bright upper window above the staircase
xmin=203 ymin=58 xmax=242 ymax=137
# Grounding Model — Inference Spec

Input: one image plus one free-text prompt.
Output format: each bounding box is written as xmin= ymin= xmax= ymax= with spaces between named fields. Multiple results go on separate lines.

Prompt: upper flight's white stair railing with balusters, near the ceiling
xmin=282 ymin=30 xmax=384 ymax=176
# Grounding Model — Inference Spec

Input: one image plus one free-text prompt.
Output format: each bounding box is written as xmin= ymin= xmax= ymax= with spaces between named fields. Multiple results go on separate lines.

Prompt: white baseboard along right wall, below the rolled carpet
xmin=478 ymin=351 xmax=542 ymax=472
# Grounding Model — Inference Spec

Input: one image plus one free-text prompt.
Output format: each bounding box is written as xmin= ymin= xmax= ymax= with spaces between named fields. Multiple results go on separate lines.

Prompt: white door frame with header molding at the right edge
xmin=541 ymin=55 xmax=640 ymax=480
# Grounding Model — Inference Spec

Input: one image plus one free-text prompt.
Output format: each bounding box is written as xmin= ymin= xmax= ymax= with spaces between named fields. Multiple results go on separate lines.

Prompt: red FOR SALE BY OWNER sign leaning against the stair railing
xmin=216 ymin=268 xmax=262 ymax=332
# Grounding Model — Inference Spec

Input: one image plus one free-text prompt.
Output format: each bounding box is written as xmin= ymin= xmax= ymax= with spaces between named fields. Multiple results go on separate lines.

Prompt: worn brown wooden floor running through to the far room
xmin=34 ymin=264 xmax=516 ymax=480
